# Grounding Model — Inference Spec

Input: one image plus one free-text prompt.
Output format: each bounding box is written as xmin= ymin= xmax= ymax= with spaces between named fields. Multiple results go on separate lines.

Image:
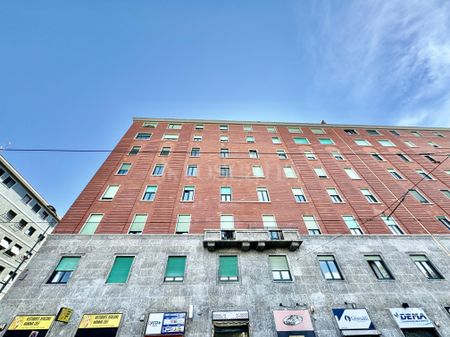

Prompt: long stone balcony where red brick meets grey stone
xmin=203 ymin=228 xmax=302 ymax=252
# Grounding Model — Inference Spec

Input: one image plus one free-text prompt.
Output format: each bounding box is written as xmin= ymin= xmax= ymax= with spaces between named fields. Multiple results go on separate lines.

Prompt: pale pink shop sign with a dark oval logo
xmin=273 ymin=310 xmax=316 ymax=337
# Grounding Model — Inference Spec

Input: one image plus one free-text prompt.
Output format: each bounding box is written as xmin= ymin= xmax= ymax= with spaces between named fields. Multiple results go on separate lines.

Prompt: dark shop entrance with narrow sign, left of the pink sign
xmin=212 ymin=310 xmax=250 ymax=337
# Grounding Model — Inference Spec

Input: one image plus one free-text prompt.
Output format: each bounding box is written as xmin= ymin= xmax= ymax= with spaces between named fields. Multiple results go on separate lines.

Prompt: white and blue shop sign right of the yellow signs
xmin=145 ymin=312 xmax=187 ymax=336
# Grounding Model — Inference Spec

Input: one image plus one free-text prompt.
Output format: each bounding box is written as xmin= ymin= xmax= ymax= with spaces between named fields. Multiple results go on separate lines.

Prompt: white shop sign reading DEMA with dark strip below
xmin=389 ymin=308 xmax=439 ymax=337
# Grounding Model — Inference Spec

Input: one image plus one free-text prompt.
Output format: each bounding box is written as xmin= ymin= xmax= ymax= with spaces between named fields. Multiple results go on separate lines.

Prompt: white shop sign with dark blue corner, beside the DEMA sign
xmin=333 ymin=308 xmax=380 ymax=337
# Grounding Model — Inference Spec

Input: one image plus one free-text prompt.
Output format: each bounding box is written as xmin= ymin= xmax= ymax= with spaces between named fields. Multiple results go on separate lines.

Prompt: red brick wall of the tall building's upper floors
xmin=55 ymin=121 xmax=450 ymax=234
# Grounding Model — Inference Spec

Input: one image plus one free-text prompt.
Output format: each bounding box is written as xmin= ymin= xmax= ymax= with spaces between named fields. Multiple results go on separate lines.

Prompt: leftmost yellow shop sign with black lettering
xmin=4 ymin=315 xmax=55 ymax=337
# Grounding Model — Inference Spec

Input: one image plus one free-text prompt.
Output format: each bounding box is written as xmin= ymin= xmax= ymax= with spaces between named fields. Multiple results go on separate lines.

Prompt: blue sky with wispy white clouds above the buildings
xmin=0 ymin=0 xmax=450 ymax=214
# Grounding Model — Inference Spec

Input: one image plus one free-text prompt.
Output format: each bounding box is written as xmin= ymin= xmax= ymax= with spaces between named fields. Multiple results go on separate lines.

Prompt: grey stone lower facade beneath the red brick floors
xmin=0 ymin=235 xmax=450 ymax=337
